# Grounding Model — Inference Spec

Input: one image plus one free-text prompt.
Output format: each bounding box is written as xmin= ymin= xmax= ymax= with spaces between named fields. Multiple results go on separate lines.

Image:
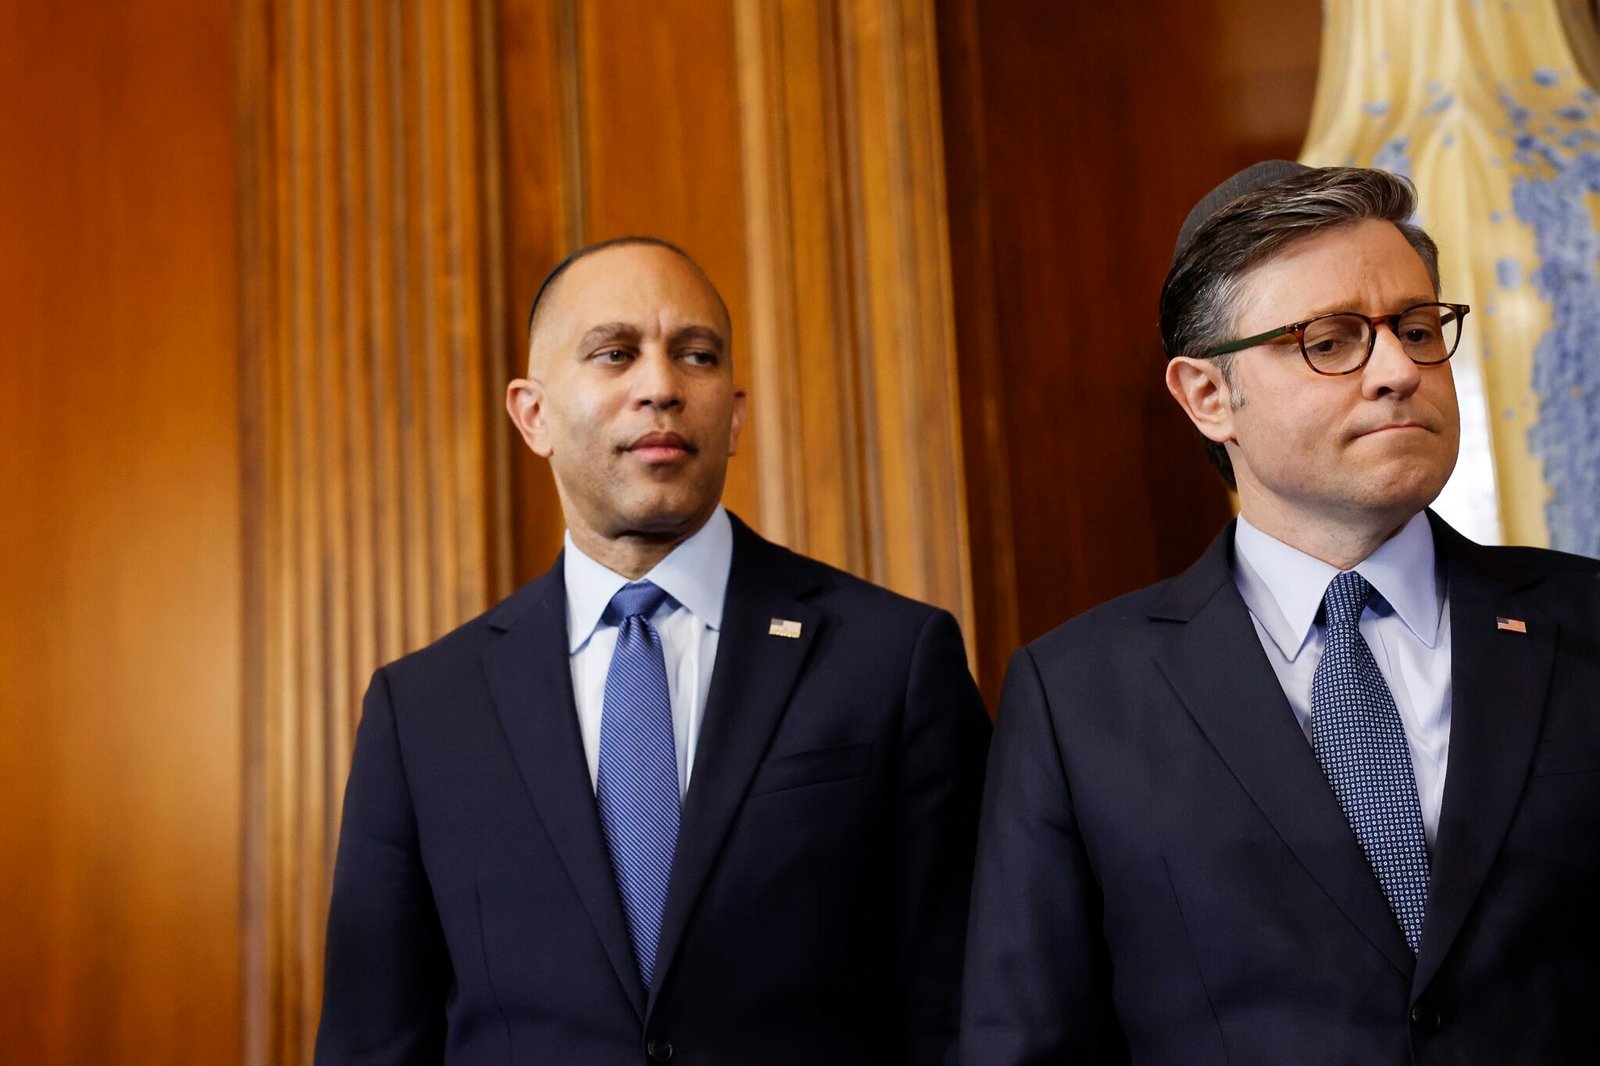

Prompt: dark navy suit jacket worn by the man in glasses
xmin=962 ymin=515 xmax=1600 ymax=1066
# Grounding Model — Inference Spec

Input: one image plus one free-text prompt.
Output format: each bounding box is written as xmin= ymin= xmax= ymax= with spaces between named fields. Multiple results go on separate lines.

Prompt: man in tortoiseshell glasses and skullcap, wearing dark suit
xmin=962 ymin=163 xmax=1600 ymax=1066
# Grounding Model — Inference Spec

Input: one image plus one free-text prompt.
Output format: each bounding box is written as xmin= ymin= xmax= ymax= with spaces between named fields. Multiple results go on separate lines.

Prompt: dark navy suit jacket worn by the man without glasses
xmin=317 ymin=520 xmax=989 ymax=1066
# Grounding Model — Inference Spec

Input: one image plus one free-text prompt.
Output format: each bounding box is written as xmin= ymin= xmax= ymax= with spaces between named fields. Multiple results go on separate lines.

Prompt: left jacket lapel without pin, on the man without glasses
xmin=483 ymin=560 xmax=645 ymax=1020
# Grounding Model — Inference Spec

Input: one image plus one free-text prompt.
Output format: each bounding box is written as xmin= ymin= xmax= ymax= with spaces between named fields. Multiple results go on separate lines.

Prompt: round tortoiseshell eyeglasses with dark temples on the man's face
xmin=1202 ymin=304 xmax=1472 ymax=376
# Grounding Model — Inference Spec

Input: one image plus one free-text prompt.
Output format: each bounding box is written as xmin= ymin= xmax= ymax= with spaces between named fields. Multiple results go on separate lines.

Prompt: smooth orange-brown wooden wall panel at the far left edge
xmin=0 ymin=0 xmax=242 ymax=1066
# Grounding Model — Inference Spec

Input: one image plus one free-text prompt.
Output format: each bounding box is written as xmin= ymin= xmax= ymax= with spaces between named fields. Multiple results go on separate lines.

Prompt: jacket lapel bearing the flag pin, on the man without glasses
xmin=646 ymin=515 xmax=824 ymax=1020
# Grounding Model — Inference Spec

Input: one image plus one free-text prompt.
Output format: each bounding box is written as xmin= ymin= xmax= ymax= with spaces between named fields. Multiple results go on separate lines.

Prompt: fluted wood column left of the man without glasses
xmin=240 ymin=0 xmax=507 ymax=1063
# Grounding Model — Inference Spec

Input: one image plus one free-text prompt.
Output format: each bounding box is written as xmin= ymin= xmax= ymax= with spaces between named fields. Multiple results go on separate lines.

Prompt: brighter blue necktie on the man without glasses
xmin=595 ymin=581 xmax=678 ymax=988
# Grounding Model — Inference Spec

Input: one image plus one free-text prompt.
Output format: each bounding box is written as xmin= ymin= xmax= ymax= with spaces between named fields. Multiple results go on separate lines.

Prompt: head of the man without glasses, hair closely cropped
xmin=512 ymin=245 xmax=744 ymax=539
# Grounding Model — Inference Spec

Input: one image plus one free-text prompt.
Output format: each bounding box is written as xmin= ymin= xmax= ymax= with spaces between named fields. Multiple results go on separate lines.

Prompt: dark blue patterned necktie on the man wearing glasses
xmin=1310 ymin=570 xmax=1427 ymax=952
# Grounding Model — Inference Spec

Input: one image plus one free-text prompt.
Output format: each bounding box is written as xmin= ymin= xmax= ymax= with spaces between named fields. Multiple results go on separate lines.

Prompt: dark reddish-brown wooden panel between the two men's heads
xmin=938 ymin=0 xmax=1318 ymax=698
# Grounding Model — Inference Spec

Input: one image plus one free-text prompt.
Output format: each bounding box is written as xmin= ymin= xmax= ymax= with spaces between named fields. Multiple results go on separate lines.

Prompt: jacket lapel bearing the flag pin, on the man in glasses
xmin=1413 ymin=515 xmax=1557 ymax=992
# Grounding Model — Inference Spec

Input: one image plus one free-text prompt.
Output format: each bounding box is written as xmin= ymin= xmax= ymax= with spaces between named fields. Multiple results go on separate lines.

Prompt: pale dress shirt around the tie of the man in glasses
xmin=1234 ymin=514 xmax=1450 ymax=847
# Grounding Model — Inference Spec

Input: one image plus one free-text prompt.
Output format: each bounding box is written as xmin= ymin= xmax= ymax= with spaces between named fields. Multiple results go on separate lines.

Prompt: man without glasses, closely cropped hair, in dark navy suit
xmin=317 ymin=238 xmax=989 ymax=1066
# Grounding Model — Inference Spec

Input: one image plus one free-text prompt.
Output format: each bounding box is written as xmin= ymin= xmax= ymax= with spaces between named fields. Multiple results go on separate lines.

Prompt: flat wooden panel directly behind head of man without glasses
xmin=501 ymin=0 xmax=758 ymax=581
